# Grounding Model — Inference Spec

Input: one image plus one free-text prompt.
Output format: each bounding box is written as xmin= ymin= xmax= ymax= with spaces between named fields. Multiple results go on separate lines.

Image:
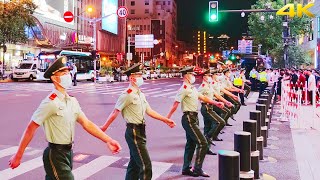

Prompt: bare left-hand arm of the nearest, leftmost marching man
xmin=9 ymin=121 xmax=39 ymax=169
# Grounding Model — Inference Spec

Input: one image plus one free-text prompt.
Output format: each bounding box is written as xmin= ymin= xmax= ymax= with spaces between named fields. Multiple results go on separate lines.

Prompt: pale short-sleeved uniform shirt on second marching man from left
xmin=115 ymin=86 xmax=150 ymax=124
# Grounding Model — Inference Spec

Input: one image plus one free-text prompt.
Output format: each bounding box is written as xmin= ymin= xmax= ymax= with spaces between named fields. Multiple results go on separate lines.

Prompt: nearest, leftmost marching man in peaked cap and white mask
xmin=9 ymin=56 xmax=121 ymax=180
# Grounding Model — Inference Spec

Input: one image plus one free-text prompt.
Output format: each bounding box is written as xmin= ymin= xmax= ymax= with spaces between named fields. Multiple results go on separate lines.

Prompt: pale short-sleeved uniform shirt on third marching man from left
xmin=175 ymin=83 xmax=199 ymax=112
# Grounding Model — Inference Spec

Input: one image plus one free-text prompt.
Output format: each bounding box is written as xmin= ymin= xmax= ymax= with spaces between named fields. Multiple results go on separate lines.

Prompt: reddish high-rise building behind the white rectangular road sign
xmin=126 ymin=0 xmax=177 ymax=66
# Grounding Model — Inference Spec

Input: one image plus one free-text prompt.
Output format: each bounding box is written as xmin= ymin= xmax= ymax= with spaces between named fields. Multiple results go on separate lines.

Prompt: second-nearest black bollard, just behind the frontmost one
xmin=234 ymin=131 xmax=251 ymax=172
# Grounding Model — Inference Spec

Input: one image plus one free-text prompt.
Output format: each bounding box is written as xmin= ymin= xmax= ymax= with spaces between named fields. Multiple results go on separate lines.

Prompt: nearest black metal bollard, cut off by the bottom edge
xmin=218 ymin=150 xmax=240 ymax=180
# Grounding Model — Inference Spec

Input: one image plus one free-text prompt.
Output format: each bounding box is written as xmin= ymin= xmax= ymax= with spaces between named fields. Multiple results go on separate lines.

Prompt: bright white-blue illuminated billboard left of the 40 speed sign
xmin=102 ymin=0 xmax=118 ymax=34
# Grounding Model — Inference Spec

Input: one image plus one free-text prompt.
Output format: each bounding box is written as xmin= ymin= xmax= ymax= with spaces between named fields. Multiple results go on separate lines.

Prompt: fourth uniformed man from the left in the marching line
xmin=198 ymin=70 xmax=226 ymax=155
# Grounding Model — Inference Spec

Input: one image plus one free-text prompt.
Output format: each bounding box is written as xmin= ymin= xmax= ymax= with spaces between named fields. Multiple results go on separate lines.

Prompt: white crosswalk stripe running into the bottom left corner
xmin=0 ymin=156 xmax=43 ymax=180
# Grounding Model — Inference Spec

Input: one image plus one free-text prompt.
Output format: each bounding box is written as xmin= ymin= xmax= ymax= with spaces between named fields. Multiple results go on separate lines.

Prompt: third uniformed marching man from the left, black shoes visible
xmin=167 ymin=67 xmax=224 ymax=177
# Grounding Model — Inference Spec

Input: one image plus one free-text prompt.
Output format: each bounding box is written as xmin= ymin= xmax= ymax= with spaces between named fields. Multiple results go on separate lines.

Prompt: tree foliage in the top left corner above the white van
xmin=0 ymin=0 xmax=36 ymax=44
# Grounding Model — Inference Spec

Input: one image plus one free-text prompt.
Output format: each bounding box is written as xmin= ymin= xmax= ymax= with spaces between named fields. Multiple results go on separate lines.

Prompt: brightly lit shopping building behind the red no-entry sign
xmin=0 ymin=0 xmax=125 ymax=69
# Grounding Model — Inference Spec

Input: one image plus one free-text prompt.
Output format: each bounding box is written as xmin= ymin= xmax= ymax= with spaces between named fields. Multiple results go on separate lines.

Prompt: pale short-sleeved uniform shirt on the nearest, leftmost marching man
xmin=31 ymin=90 xmax=85 ymax=144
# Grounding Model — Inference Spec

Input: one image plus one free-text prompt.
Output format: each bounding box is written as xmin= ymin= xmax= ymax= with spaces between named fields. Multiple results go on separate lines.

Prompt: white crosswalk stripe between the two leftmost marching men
xmin=72 ymin=156 xmax=121 ymax=180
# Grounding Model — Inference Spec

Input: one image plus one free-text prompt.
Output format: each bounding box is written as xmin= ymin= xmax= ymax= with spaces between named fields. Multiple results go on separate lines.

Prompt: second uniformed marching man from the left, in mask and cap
xmin=101 ymin=64 xmax=176 ymax=180
